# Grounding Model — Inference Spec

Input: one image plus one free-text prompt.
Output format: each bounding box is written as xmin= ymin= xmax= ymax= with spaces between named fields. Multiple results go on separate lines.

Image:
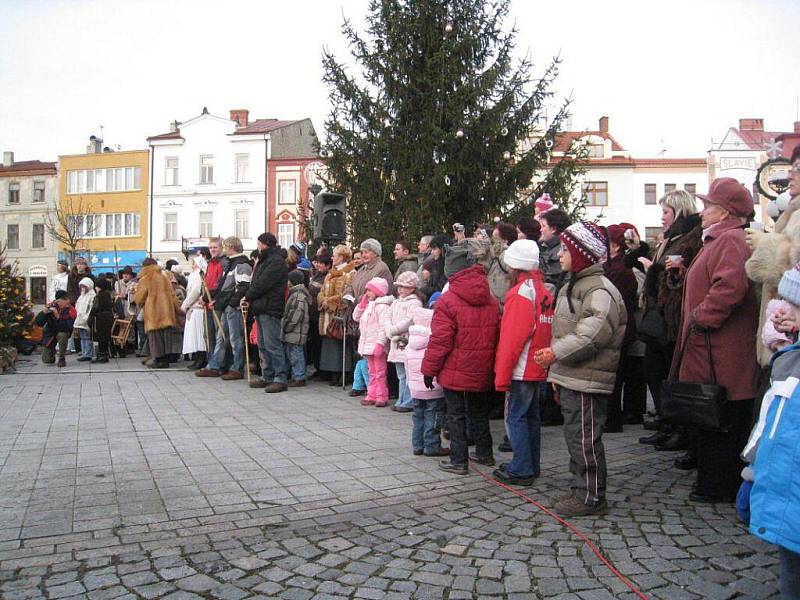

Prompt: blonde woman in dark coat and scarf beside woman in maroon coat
xmin=632 ymin=190 xmax=703 ymax=452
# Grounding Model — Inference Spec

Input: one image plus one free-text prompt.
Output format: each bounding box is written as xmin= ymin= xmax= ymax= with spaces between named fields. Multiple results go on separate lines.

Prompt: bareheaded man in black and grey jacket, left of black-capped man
xmin=194 ymin=237 xmax=253 ymax=381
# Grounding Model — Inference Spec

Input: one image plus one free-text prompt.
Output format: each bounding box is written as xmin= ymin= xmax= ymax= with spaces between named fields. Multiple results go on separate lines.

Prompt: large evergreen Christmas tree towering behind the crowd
xmin=322 ymin=0 xmax=582 ymax=248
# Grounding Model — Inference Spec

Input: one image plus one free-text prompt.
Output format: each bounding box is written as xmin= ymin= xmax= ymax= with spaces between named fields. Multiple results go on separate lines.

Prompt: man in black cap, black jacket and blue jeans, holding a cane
xmin=244 ymin=232 xmax=289 ymax=394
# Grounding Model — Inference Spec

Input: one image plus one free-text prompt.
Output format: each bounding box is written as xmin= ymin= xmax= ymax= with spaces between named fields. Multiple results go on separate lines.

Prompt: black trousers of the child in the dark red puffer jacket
xmin=444 ymin=388 xmax=493 ymax=465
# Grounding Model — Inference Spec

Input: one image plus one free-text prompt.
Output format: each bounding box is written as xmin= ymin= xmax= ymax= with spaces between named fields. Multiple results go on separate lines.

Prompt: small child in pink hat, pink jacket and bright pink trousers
xmin=353 ymin=277 xmax=394 ymax=406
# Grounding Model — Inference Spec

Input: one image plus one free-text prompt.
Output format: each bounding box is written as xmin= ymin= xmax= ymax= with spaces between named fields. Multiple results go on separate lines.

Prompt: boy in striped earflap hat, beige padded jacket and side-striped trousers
xmin=535 ymin=222 xmax=627 ymax=517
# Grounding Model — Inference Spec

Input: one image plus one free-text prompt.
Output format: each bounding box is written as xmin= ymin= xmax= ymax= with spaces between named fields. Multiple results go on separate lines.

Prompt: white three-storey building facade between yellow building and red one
xmin=148 ymin=109 xmax=270 ymax=259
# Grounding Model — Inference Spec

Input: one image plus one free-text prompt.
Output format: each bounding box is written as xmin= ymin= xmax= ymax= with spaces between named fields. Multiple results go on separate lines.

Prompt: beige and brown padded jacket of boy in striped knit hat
xmin=547 ymin=264 xmax=628 ymax=394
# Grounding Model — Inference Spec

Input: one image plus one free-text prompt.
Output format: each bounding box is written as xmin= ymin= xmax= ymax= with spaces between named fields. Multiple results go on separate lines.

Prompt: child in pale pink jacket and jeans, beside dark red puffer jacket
xmin=405 ymin=308 xmax=450 ymax=456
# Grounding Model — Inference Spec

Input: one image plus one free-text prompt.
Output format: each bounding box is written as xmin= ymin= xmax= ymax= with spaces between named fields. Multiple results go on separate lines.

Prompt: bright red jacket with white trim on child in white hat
xmin=494 ymin=269 xmax=555 ymax=392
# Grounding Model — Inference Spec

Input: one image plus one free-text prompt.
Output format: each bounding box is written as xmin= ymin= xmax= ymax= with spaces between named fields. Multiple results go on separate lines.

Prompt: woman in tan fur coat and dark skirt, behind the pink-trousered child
xmin=317 ymin=244 xmax=356 ymax=385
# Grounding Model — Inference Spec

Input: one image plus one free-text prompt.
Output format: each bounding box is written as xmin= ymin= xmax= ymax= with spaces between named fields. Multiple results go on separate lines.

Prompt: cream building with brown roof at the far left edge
xmin=0 ymin=152 xmax=58 ymax=306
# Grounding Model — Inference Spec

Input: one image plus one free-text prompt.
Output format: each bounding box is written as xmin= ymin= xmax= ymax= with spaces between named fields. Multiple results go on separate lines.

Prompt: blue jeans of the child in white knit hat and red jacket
xmin=506 ymin=381 xmax=542 ymax=477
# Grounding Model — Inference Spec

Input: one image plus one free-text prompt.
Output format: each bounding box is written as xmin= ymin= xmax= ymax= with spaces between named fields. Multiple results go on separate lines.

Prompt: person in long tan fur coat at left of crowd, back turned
xmin=135 ymin=258 xmax=180 ymax=369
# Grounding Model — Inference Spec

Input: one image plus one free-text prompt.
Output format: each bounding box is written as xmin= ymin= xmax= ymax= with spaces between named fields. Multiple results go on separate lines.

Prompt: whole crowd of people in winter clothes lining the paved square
xmin=23 ymin=151 xmax=800 ymax=597
